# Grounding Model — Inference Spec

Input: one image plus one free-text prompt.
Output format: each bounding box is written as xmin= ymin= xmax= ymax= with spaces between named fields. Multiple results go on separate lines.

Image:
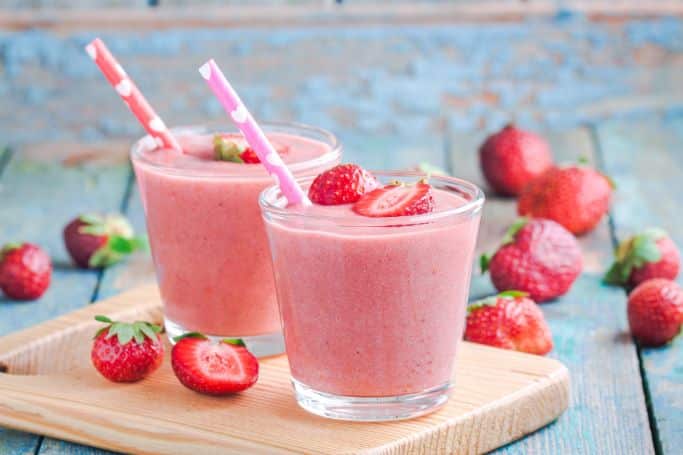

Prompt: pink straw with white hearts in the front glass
xmin=199 ymin=59 xmax=311 ymax=205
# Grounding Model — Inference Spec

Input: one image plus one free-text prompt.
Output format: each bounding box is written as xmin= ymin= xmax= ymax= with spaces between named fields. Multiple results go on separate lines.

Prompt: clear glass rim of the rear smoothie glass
xmin=130 ymin=121 xmax=343 ymax=180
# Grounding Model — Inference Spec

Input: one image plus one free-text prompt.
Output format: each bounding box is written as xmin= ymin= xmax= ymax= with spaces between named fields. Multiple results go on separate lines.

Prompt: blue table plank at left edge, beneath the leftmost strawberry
xmin=0 ymin=143 xmax=129 ymax=453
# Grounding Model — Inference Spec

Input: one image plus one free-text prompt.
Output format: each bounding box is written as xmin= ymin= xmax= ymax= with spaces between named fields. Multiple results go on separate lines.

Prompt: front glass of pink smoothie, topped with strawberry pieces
xmin=259 ymin=172 xmax=484 ymax=421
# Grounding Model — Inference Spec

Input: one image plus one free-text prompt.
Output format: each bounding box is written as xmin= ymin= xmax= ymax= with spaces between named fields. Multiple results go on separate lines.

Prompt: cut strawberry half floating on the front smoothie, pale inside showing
xmin=353 ymin=180 xmax=434 ymax=217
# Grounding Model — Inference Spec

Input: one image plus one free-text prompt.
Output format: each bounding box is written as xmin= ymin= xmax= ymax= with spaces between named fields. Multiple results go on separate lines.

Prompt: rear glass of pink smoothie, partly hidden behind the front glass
xmin=131 ymin=123 xmax=341 ymax=356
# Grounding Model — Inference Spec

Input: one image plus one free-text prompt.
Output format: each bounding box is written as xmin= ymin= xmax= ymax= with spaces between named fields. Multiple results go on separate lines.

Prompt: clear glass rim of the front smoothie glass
xmin=258 ymin=170 xmax=486 ymax=227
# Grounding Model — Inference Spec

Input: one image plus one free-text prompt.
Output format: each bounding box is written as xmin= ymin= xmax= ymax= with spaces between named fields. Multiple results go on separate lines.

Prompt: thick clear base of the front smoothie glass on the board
xmin=292 ymin=378 xmax=451 ymax=422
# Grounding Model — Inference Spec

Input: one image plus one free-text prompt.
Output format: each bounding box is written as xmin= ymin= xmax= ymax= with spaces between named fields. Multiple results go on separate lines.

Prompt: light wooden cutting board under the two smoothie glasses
xmin=0 ymin=286 xmax=569 ymax=455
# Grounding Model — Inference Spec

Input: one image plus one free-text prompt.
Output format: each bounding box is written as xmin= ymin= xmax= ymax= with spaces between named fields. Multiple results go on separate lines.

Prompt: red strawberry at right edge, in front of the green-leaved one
xmin=627 ymin=278 xmax=683 ymax=346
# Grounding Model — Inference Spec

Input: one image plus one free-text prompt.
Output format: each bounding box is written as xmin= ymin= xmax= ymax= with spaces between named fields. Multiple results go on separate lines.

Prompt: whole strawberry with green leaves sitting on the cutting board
xmin=90 ymin=316 xmax=164 ymax=382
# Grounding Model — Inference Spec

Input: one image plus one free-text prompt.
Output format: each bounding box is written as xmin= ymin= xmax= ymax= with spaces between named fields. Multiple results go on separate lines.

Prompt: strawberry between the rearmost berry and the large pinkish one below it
xmin=517 ymin=165 xmax=613 ymax=235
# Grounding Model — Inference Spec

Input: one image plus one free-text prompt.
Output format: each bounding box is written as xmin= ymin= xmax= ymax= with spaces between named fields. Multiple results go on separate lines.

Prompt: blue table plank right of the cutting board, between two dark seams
xmin=450 ymin=125 xmax=654 ymax=454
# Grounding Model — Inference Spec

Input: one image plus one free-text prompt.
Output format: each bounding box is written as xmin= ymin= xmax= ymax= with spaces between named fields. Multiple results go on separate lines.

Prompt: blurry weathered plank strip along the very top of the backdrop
xmin=0 ymin=0 xmax=683 ymax=31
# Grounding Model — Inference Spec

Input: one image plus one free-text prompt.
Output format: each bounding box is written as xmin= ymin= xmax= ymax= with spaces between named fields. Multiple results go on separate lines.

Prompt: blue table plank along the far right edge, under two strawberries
xmin=597 ymin=115 xmax=683 ymax=454
